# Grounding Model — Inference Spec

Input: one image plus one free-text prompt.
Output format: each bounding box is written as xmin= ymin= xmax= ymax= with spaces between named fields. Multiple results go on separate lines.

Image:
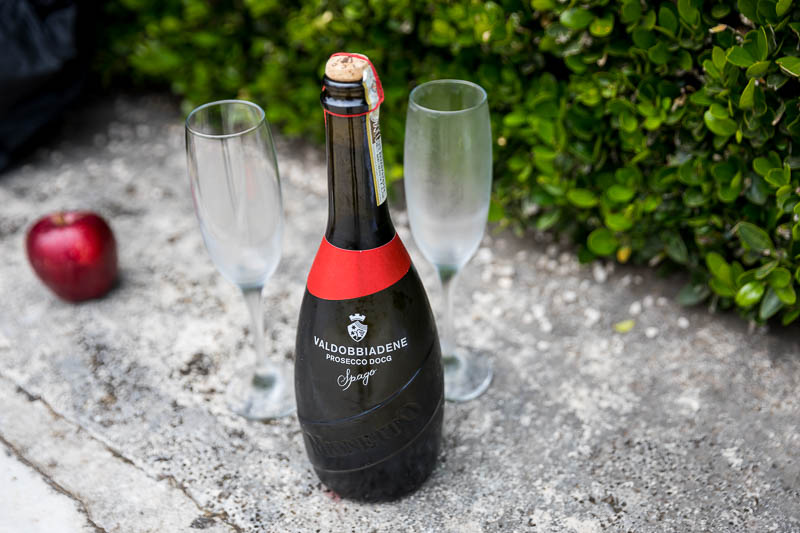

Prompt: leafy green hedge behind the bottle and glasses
xmin=98 ymin=0 xmax=800 ymax=323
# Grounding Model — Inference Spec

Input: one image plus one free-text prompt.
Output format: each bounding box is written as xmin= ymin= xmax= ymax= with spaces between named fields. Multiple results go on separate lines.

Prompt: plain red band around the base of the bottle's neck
xmin=308 ymin=233 xmax=411 ymax=300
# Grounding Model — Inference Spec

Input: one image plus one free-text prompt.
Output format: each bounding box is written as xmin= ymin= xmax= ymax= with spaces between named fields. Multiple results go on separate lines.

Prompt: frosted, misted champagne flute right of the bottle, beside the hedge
xmin=403 ymin=80 xmax=492 ymax=401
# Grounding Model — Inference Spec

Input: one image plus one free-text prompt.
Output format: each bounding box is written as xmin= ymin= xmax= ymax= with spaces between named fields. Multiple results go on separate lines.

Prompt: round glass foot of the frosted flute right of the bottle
xmin=442 ymin=349 xmax=493 ymax=402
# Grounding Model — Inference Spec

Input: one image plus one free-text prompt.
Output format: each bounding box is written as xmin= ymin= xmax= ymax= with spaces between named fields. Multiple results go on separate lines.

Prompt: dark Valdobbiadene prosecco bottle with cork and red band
xmin=295 ymin=54 xmax=444 ymax=501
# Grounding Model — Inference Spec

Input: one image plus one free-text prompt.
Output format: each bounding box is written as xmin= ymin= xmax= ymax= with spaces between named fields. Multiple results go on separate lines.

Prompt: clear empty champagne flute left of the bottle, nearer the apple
xmin=186 ymin=100 xmax=295 ymax=420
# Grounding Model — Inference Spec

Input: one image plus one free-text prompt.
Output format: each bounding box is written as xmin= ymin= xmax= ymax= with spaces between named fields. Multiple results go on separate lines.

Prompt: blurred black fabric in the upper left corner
xmin=0 ymin=0 xmax=85 ymax=170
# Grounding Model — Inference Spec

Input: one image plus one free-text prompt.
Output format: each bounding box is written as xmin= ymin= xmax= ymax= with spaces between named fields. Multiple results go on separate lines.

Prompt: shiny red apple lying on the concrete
xmin=25 ymin=211 xmax=117 ymax=302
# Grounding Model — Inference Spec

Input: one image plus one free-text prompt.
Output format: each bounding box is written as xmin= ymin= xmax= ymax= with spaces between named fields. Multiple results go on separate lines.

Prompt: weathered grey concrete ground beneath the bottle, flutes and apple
xmin=0 ymin=97 xmax=800 ymax=533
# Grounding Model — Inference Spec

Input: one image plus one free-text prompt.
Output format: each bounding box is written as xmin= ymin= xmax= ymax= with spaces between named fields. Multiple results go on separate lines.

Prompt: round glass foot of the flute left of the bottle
xmin=226 ymin=362 xmax=295 ymax=420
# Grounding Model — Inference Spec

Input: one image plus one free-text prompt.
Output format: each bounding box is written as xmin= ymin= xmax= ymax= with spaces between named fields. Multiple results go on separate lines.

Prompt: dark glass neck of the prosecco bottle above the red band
xmin=321 ymin=77 xmax=395 ymax=250
